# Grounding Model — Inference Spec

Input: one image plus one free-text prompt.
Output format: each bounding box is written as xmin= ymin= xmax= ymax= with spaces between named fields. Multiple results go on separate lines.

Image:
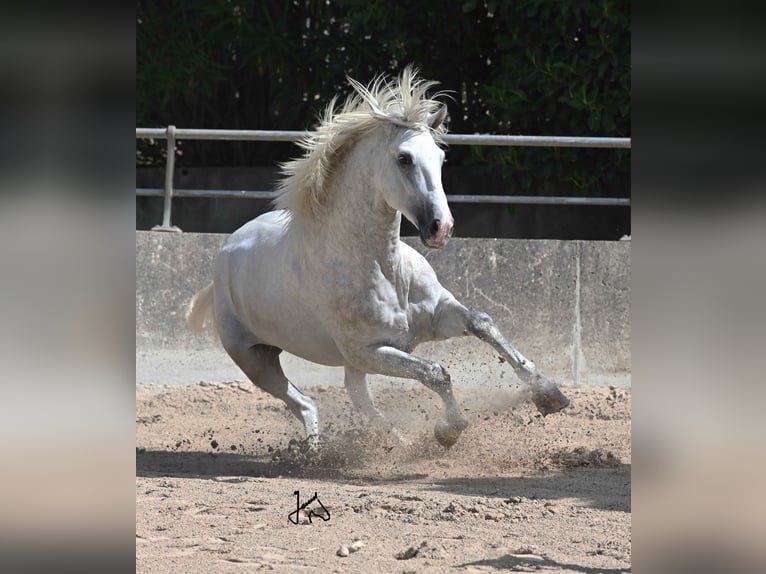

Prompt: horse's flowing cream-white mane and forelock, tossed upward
xmin=275 ymin=66 xmax=446 ymax=219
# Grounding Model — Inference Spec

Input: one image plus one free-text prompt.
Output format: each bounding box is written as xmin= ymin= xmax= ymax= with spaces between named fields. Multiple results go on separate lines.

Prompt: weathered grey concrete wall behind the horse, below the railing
xmin=136 ymin=231 xmax=631 ymax=386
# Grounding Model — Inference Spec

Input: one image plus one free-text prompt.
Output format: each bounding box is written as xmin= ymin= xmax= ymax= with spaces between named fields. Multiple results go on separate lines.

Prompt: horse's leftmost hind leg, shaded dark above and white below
xmin=226 ymin=344 xmax=319 ymax=447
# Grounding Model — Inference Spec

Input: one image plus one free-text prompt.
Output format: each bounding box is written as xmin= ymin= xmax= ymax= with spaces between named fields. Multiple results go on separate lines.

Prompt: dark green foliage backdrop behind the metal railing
xmin=137 ymin=0 xmax=630 ymax=195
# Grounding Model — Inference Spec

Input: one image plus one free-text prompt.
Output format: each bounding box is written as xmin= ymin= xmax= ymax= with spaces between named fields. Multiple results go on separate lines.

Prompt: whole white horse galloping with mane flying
xmin=187 ymin=68 xmax=569 ymax=447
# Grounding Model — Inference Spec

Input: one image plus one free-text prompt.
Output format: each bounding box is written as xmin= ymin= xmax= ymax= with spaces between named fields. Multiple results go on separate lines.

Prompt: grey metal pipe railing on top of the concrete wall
xmin=136 ymin=126 xmax=631 ymax=232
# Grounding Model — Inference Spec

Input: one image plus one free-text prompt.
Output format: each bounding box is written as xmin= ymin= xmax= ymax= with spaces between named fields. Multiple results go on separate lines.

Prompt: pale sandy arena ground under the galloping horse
xmin=136 ymin=381 xmax=631 ymax=574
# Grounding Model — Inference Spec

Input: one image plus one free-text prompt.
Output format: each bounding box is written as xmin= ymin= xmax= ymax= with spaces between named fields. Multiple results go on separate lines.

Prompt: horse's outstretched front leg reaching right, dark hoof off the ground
xmin=434 ymin=298 xmax=569 ymax=415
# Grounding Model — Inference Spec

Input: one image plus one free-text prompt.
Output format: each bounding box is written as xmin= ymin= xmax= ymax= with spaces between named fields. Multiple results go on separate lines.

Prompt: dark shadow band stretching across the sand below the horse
xmin=136 ymin=451 xmax=631 ymax=512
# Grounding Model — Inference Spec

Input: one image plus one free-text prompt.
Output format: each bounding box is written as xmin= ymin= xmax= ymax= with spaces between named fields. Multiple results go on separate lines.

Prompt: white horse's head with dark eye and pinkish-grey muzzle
xmin=380 ymin=106 xmax=455 ymax=249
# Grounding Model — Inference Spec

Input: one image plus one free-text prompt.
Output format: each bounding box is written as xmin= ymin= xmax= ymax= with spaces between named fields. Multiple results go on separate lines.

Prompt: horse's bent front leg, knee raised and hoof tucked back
xmin=348 ymin=345 xmax=468 ymax=447
